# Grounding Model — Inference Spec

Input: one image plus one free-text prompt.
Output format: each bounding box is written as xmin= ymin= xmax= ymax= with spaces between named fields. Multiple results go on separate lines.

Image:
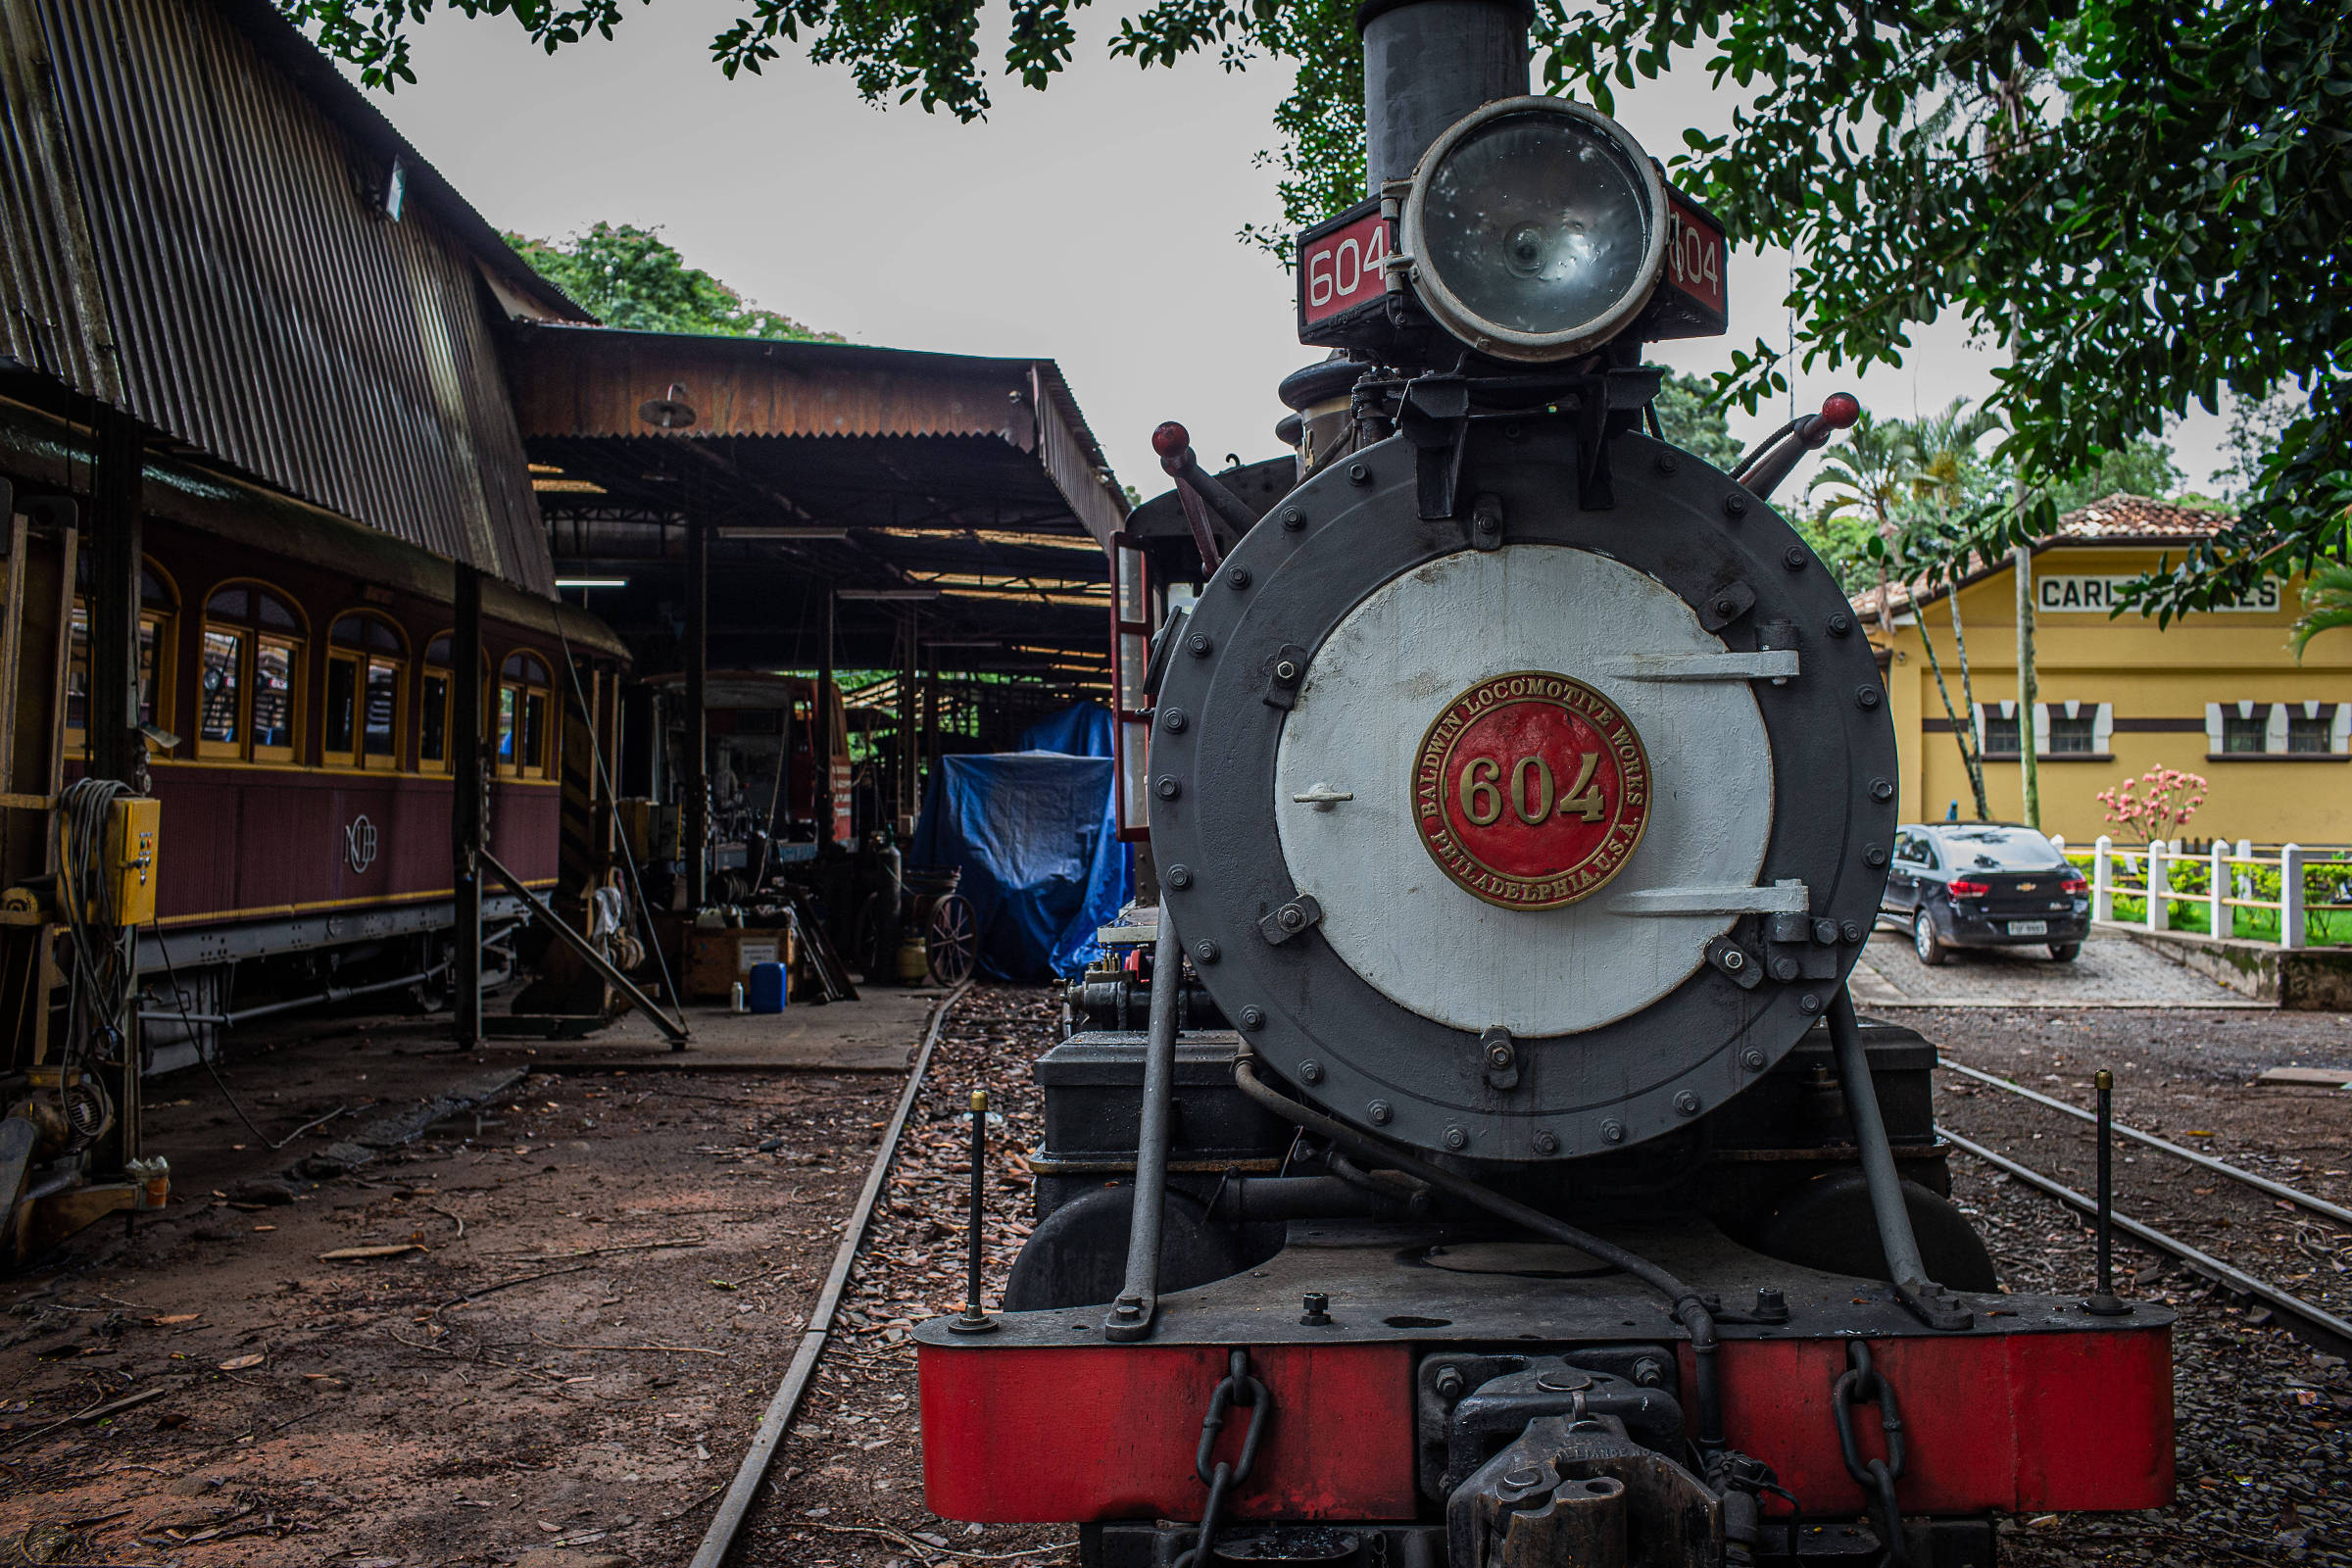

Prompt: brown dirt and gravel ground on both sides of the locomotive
xmin=0 ymin=987 xmax=2352 ymax=1568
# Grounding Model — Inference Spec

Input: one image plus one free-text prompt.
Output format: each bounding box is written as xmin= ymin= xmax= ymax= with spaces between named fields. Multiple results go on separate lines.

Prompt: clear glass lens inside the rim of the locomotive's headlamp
xmin=1421 ymin=113 xmax=1651 ymax=334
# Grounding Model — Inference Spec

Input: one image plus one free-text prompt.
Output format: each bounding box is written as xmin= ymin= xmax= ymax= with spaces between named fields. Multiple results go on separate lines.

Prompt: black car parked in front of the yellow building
xmin=1884 ymin=823 xmax=2091 ymax=964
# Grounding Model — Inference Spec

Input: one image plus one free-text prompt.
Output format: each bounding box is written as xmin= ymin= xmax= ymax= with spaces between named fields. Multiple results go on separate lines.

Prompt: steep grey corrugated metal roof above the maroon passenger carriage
xmin=0 ymin=0 xmax=581 ymax=592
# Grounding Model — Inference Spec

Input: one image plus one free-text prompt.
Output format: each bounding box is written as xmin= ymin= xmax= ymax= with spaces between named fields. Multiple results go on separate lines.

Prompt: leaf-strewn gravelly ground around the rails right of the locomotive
xmin=1903 ymin=1010 xmax=2352 ymax=1568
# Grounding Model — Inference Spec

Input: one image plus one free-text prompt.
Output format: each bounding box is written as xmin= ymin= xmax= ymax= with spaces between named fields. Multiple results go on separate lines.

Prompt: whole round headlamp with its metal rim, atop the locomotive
xmin=1401 ymin=99 xmax=1665 ymax=360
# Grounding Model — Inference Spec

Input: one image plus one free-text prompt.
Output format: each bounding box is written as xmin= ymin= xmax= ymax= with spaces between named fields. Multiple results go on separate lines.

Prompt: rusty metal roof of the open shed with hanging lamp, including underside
xmin=511 ymin=326 xmax=1127 ymax=674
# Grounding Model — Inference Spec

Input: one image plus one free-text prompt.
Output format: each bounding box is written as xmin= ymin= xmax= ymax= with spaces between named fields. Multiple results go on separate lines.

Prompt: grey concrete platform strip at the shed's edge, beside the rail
xmin=482 ymin=985 xmax=946 ymax=1072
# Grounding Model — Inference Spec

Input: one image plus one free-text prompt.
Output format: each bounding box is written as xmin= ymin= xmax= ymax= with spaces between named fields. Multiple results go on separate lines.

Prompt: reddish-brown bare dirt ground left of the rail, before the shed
xmin=0 ymin=1020 xmax=904 ymax=1568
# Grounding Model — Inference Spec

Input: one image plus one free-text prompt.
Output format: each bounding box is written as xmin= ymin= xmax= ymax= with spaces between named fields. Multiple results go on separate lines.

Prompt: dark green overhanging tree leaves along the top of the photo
xmin=277 ymin=0 xmax=2352 ymax=618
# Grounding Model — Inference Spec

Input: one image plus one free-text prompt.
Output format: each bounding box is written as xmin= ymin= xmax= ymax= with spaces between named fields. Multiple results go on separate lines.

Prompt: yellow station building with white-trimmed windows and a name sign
xmin=1853 ymin=496 xmax=2352 ymax=847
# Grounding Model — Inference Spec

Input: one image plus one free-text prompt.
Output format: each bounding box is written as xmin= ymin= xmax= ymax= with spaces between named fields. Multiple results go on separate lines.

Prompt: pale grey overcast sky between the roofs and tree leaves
xmin=376 ymin=0 xmax=2221 ymax=496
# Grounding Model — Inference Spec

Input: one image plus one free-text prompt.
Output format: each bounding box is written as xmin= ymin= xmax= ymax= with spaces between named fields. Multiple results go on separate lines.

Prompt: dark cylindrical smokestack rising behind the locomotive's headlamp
xmin=1354 ymin=0 xmax=1536 ymax=195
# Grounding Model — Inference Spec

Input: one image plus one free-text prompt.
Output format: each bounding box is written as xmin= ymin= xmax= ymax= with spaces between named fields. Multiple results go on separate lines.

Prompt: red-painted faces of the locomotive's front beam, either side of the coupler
xmin=919 ymin=1326 xmax=2174 ymax=1523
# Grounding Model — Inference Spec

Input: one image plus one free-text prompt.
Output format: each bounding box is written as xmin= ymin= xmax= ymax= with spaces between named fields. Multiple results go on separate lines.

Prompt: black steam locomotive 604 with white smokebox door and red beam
xmin=917 ymin=0 xmax=2174 ymax=1568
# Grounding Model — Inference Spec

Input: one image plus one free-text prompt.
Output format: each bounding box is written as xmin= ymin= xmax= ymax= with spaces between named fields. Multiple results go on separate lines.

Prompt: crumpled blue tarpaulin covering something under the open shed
xmin=907 ymin=703 xmax=1131 ymax=980
